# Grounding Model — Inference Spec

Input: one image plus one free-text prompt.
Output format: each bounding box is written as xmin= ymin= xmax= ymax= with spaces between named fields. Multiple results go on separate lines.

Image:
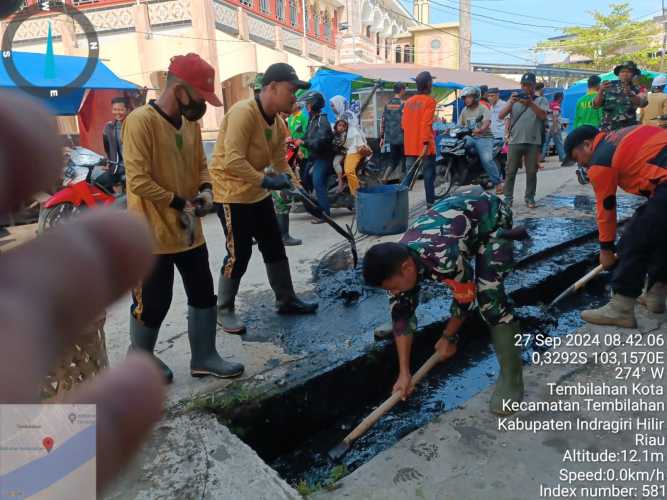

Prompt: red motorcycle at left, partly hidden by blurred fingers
xmin=37 ymin=147 xmax=126 ymax=233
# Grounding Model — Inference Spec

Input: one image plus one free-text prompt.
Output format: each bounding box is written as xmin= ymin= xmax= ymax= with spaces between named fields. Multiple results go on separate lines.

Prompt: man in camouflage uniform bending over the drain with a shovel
xmin=363 ymin=190 xmax=527 ymax=414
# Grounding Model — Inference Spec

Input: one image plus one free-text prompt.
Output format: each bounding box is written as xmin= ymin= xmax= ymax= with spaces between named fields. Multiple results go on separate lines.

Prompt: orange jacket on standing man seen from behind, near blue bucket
xmin=401 ymin=94 xmax=436 ymax=156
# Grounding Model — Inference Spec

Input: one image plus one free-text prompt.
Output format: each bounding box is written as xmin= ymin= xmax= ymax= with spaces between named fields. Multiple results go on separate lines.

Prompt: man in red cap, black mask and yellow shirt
xmin=123 ymin=54 xmax=243 ymax=382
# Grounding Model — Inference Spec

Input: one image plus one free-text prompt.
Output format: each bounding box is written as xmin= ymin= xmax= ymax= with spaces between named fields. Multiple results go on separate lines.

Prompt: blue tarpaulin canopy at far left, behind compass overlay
xmin=0 ymin=52 xmax=139 ymax=115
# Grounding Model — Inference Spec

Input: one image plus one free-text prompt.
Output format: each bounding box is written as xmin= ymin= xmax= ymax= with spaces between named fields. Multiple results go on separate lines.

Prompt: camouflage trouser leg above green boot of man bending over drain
xmin=475 ymin=238 xmax=514 ymax=326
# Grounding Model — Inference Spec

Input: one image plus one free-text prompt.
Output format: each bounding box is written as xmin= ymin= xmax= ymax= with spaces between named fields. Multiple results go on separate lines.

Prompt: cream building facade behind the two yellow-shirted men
xmin=6 ymin=0 xmax=343 ymax=133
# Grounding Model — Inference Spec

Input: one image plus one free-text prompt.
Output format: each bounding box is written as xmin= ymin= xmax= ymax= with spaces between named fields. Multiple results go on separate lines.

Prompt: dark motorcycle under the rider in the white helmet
xmin=436 ymin=127 xmax=504 ymax=196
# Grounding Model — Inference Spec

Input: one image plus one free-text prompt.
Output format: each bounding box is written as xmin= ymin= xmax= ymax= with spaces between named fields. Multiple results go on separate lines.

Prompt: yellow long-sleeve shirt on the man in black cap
xmin=210 ymin=99 xmax=292 ymax=204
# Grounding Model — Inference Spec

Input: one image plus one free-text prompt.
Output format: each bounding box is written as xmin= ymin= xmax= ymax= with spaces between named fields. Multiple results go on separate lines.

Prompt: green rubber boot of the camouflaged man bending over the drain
xmin=489 ymin=321 xmax=523 ymax=415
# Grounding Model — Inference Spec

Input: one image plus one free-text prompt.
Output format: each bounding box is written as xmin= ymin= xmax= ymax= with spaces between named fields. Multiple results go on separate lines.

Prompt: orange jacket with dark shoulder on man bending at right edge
xmin=588 ymin=125 xmax=667 ymax=250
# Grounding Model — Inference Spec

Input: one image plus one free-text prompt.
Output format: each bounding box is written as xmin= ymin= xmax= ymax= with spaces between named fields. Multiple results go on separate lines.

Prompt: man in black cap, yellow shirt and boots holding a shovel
xmin=211 ymin=63 xmax=317 ymax=334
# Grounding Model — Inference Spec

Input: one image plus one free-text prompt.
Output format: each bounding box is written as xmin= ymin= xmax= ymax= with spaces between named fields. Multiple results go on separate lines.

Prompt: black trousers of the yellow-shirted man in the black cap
xmin=216 ymin=196 xmax=287 ymax=279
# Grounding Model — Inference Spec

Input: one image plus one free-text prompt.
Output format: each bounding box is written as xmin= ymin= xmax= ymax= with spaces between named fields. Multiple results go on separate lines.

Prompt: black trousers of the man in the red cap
xmin=130 ymin=245 xmax=216 ymax=328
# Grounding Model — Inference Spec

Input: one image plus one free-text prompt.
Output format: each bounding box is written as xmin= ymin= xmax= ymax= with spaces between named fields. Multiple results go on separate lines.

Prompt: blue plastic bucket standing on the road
xmin=357 ymin=184 xmax=410 ymax=236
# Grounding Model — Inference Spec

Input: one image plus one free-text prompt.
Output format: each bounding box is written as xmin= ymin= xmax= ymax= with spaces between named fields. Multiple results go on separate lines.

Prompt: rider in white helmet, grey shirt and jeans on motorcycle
xmin=458 ymin=87 xmax=503 ymax=194
